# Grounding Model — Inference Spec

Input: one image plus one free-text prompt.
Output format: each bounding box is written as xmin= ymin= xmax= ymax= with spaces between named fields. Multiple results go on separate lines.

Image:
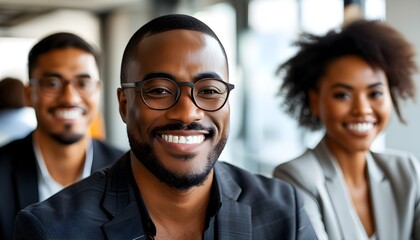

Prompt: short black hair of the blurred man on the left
xmin=28 ymin=32 xmax=100 ymax=78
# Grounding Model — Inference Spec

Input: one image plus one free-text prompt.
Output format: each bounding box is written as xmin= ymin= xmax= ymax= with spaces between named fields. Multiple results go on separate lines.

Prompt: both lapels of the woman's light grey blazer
xmin=314 ymin=138 xmax=398 ymax=239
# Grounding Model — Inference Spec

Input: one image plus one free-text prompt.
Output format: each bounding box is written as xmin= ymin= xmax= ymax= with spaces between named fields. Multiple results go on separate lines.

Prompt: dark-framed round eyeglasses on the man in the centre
xmin=121 ymin=78 xmax=235 ymax=112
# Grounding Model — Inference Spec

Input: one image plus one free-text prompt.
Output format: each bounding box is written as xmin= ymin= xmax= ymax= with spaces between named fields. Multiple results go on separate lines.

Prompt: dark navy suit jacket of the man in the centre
xmin=15 ymin=154 xmax=316 ymax=240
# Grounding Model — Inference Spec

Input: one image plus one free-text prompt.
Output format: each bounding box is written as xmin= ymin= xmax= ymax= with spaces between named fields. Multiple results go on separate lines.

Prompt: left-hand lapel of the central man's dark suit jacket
xmin=102 ymin=153 xmax=146 ymax=239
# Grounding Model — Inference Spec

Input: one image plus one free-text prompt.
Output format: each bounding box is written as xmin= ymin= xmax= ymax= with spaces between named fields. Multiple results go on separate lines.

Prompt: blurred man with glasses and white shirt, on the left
xmin=0 ymin=33 xmax=123 ymax=239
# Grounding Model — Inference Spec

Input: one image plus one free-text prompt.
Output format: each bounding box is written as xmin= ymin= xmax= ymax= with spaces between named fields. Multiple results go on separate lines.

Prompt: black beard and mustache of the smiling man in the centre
xmin=127 ymin=123 xmax=227 ymax=190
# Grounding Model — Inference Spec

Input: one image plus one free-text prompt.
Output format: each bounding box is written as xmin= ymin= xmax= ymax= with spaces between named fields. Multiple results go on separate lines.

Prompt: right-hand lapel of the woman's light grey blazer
xmin=367 ymin=154 xmax=399 ymax=240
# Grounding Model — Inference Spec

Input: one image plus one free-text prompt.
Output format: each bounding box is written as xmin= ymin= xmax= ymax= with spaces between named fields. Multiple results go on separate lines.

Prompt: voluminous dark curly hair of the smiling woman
xmin=277 ymin=20 xmax=417 ymax=130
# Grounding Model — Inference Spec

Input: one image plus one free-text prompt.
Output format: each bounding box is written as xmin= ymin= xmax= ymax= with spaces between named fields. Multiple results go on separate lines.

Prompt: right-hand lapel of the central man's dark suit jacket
xmin=215 ymin=163 xmax=251 ymax=240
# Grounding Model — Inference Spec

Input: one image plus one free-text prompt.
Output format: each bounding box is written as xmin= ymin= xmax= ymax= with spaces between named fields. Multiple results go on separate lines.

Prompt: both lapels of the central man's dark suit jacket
xmin=103 ymin=158 xmax=252 ymax=240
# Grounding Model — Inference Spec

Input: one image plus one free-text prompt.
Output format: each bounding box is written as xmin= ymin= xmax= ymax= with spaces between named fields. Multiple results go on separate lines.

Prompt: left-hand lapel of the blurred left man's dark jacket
xmin=13 ymin=134 xmax=39 ymax=209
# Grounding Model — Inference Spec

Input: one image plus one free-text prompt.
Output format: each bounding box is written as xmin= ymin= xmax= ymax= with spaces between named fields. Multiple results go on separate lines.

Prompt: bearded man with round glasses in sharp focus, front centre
xmin=15 ymin=15 xmax=315 ymax=240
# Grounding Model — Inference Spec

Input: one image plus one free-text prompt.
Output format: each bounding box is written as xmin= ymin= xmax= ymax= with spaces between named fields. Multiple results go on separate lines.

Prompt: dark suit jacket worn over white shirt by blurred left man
xmin=0 ymin=134 xmax=123 ymax=239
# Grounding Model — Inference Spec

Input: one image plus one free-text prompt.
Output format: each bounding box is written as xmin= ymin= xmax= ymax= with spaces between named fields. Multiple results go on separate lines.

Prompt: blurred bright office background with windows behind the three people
xmin=0 ymin=0 xmax=420 ymax=176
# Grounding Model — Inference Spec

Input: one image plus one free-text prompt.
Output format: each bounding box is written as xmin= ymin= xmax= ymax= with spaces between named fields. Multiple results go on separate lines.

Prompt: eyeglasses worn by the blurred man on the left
xmin=30 ymin=76 xmax=100 ymax=97
